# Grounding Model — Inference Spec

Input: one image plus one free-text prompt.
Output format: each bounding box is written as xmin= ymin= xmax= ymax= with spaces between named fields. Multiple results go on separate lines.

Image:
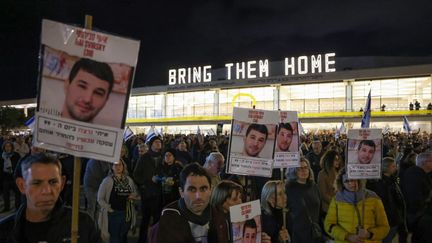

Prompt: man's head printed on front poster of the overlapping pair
xmin=243 ymin=123 xmax=268 ymax=157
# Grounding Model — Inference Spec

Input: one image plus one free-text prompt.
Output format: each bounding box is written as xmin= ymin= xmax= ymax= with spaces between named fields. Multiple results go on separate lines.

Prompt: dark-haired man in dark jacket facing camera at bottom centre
xmin=151 ymin=163 xmax=212 ymax=243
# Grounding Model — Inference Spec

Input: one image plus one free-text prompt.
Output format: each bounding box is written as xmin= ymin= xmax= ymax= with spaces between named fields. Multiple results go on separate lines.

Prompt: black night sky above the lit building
xmin=0 ymin=0 xmax=432 ymax=100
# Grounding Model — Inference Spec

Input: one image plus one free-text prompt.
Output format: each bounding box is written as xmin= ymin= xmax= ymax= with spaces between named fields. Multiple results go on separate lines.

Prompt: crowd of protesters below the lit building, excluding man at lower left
xmin=0 ymin=128 xmax=432 ymax=243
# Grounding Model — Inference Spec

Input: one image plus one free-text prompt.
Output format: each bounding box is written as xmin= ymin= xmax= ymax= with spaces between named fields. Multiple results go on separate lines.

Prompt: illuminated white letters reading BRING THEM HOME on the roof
xmin=168 ymin=53 xmax=336 ymax=85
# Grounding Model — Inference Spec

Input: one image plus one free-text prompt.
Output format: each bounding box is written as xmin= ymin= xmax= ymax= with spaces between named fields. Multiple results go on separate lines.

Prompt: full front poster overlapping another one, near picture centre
xmin=227 ymin=107 xmax=279 ymax=177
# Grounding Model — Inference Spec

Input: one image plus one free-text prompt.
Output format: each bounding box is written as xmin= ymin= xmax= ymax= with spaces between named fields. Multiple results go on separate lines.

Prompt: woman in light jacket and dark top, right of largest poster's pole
xmin=97 ymin=159 xmax=138 ymax=243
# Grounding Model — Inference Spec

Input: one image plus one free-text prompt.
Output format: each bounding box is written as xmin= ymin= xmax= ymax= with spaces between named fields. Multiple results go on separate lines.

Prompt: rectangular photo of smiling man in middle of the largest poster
xmin=38 ymin=45 xmax=133 ymax=128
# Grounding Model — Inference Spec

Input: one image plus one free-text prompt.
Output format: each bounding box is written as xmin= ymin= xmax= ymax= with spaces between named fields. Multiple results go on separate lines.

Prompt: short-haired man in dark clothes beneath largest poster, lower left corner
xmin=0 ymin=153 xmax=102 ymax=243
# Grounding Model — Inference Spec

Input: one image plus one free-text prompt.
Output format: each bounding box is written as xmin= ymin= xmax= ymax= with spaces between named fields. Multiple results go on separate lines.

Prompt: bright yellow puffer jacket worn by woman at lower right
xmin=324 ymin=190 xmax=390 ymax=243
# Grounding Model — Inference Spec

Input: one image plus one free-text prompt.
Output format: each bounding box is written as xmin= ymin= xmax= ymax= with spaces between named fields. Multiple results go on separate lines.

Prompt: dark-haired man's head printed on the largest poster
xmin=62 ymin=58 xmax=114 ymax=122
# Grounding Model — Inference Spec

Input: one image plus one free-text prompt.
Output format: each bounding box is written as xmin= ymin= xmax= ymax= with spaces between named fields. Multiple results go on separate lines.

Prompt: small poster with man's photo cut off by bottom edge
xmin=230 ymin=200 xmax=262 ymax=243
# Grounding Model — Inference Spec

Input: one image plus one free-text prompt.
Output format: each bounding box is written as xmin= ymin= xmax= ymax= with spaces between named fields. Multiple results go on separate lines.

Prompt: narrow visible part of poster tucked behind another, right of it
xmin=273 ymin=111 xmax=300 ymax=168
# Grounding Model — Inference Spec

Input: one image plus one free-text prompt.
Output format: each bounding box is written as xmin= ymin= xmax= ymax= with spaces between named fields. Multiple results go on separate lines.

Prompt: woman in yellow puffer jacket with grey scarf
xmin=324 ymin=169 xmax=390 ymax=243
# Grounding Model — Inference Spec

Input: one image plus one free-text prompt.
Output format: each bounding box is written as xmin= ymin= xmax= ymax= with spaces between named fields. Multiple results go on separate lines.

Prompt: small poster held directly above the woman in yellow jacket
xmin=346 ymin=128 xmax=382 ymax=179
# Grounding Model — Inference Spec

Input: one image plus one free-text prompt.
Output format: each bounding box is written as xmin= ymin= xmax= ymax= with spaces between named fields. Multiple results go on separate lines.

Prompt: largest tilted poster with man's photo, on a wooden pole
xmin=33 ymin=20 xmax=140 ymax=162
